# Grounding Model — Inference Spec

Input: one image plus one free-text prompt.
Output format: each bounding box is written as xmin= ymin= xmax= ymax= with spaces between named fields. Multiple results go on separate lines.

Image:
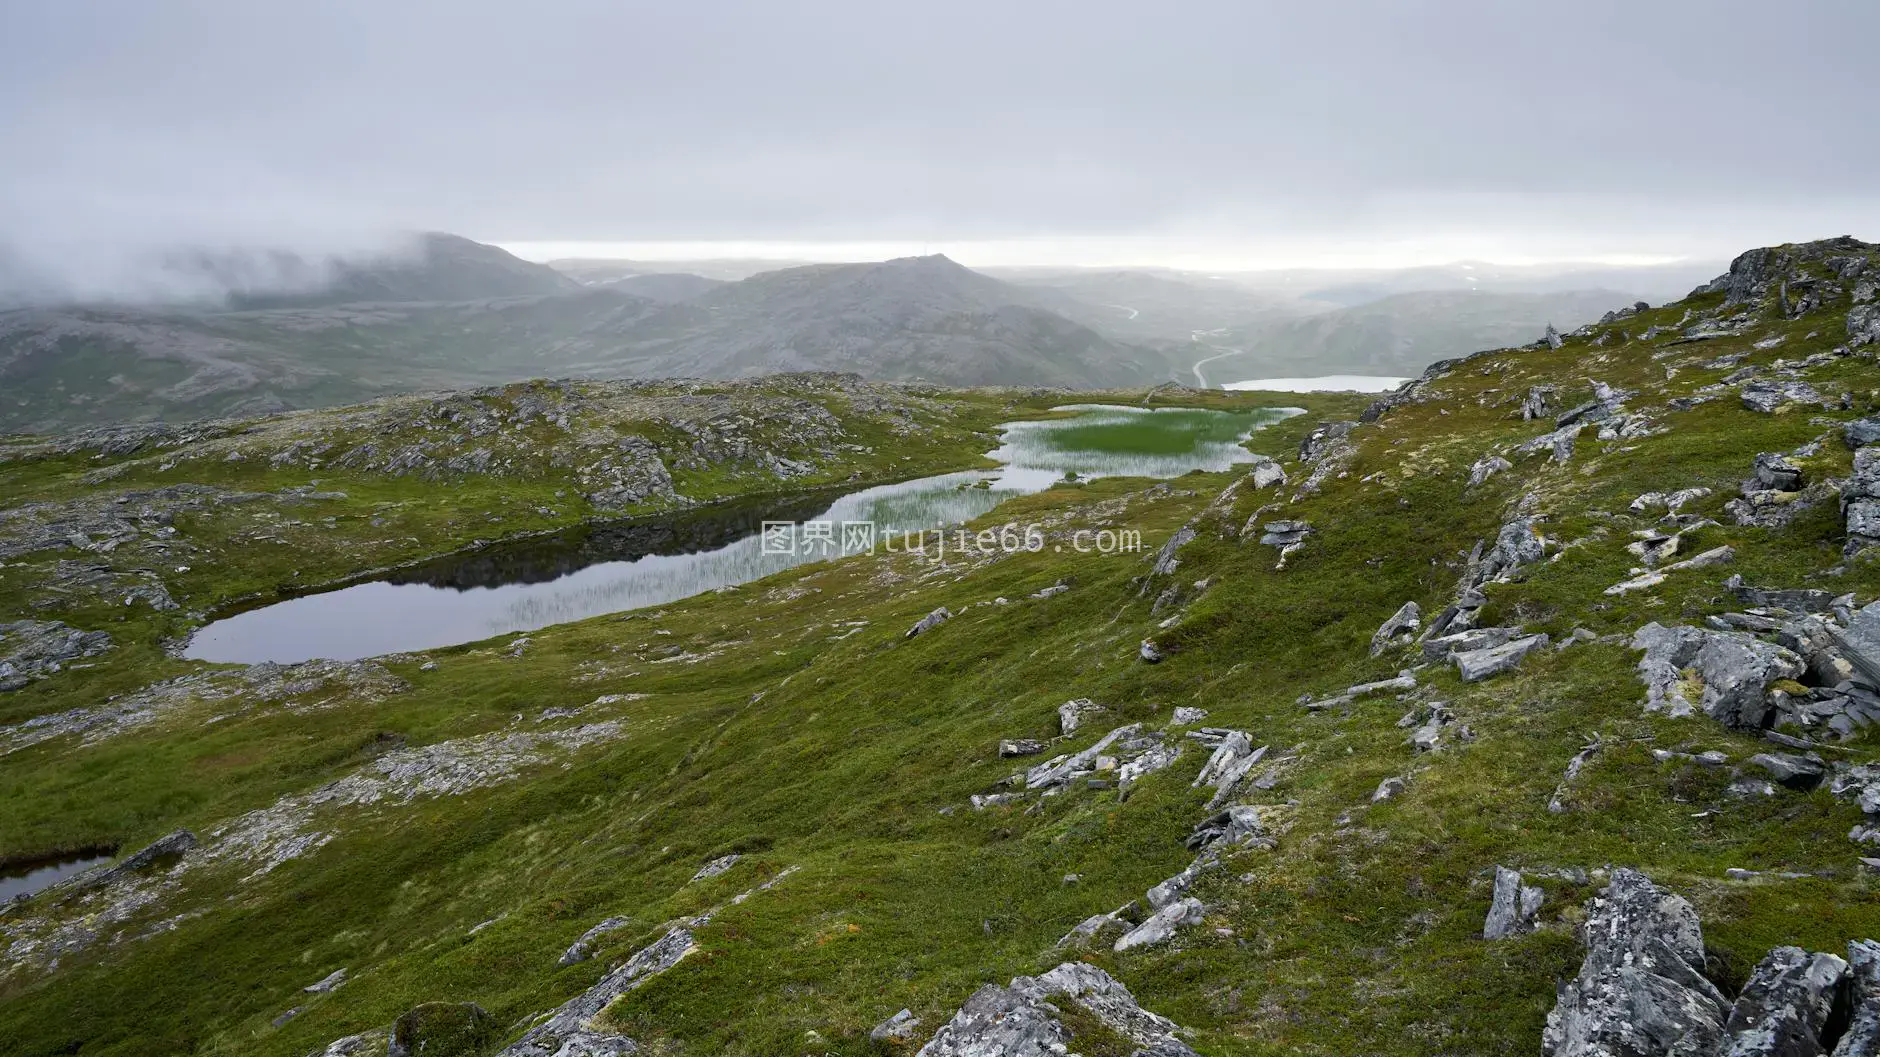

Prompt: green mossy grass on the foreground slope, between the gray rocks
xmin=0 ymin=267 xmax=1880 ymax=1055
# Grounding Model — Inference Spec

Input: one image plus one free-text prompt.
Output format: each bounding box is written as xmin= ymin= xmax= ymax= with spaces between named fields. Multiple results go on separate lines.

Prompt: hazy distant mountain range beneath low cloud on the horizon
xmin=0 ymin=235 xmax=1636 ymax=431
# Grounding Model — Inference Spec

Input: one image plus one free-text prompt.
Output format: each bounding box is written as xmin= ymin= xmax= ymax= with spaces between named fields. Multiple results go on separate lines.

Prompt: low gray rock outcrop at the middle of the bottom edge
xmin=919 ymin=961 xmax=1196 ymax=1057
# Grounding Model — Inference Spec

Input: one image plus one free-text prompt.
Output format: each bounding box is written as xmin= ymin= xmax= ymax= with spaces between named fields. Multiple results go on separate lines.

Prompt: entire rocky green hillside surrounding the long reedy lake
xmin=0 ymin=239 xmax=1880 ymax=1057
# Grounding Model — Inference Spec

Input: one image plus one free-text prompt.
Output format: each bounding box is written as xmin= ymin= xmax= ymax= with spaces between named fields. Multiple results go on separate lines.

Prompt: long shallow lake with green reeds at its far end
xmin=184 ymin=404 xmax=1299 ymax=664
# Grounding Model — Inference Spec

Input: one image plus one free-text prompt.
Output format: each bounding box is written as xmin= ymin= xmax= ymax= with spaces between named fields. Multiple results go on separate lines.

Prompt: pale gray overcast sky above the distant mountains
xmin=0 ymin=0 xmax=1880 ymax=278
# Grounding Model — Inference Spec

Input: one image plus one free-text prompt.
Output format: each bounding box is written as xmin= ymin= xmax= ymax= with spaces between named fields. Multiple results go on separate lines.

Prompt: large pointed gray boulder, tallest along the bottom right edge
xmin=1542 ymin=867 xmax=1730 ymax=1057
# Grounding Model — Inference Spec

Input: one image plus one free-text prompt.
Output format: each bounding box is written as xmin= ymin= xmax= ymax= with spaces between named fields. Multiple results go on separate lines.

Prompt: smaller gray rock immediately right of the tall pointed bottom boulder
xmin=1720 ymin=946 xmax=1848 ymax=1057
